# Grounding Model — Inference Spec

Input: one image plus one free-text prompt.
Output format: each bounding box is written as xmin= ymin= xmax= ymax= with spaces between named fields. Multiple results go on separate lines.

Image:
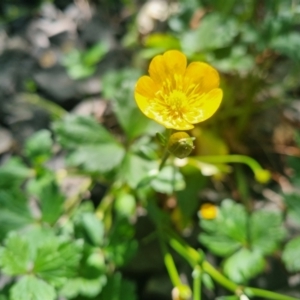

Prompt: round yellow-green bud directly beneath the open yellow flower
xmin=168 ymin=132 xmax=195 ymax=158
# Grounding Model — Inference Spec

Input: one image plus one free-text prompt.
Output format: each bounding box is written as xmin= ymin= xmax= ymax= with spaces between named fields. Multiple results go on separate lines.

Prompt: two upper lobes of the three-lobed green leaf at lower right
xmin=200 ymin=200 xmax=285 ymax=256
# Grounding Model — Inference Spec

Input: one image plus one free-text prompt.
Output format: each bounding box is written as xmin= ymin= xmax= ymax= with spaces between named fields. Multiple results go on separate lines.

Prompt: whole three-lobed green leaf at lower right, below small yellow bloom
xmin=199 ymin=200 xmax=285 ymax=283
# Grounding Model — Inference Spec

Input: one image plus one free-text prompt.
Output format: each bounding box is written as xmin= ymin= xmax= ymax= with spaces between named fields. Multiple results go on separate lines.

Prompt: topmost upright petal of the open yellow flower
xmin=149 ymin=50 xmax=186 ymax=85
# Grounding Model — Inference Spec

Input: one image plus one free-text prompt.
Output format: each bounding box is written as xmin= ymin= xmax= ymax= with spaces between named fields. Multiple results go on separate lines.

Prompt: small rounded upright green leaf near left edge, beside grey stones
xmin=24 ymin=129 xmax=53 ymax=164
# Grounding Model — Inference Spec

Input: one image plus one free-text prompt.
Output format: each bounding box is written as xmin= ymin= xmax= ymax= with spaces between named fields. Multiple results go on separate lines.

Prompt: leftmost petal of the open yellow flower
xmin=134 ymin=76 xmax=157 ymax=118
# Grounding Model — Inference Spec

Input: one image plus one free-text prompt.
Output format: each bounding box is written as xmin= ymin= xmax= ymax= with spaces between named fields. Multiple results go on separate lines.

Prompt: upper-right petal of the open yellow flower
xmin=184 ymin=62 xmax=220 ymax=93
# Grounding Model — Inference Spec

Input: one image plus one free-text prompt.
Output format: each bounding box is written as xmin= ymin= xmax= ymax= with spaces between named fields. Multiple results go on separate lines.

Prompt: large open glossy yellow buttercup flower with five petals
xmin=135 ymin=50 xmax=223 ymax=130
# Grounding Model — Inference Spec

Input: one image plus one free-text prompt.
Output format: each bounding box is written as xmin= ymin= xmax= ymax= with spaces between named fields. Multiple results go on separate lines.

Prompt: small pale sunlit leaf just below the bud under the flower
xmin=151 ymin=166 xmax=185 ymax=194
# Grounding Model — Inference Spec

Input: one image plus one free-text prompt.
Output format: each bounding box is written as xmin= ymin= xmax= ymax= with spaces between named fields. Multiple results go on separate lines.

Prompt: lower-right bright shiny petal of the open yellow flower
xmin=184 ymin=89 xmax=223 ymax=124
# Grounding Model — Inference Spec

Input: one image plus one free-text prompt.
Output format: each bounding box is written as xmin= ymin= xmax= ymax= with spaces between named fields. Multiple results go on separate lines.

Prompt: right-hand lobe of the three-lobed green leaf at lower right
xmin=250 ymin=210 xmax=285 ymax=255
